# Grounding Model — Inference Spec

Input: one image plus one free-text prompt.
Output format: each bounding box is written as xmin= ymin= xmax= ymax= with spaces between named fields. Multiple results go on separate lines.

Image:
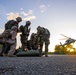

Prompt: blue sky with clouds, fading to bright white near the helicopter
xmin=0 ymin=0 xmax=76 ymax=51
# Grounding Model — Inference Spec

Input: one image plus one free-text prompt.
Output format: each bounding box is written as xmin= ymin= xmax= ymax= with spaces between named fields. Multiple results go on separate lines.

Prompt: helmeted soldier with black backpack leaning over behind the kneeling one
xmin=5 ymin=17 xmax=22 ymax=30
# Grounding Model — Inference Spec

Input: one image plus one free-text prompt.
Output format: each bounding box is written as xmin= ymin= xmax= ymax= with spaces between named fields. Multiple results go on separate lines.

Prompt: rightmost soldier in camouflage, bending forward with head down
xmin=37 ymin=26 xmax=50 ymax=57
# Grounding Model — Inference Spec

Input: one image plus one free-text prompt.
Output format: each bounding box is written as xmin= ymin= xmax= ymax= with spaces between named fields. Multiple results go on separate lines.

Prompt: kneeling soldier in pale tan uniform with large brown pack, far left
xmin=0 ymin=26 xmax=17 ymax=56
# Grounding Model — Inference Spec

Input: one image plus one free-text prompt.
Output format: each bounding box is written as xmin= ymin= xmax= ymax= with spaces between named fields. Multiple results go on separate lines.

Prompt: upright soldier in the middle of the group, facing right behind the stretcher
xmin=20 ymin=21 xmax=31 ymax=50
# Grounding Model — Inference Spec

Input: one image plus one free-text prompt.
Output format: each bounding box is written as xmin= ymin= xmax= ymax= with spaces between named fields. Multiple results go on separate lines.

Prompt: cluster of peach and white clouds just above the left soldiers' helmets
xmin=6 ymin=8 xmax=36 ymax=21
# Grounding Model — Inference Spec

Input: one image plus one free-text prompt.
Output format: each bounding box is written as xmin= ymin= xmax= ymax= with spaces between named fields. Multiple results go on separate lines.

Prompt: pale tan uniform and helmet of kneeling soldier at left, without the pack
xmin=7 ymin=26 xmax=17 ymax=56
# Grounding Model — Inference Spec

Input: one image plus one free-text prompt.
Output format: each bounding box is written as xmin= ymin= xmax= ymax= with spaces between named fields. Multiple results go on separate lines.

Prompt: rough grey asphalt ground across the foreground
xmin=0 ymin=55 xmax=76 ymax=75
